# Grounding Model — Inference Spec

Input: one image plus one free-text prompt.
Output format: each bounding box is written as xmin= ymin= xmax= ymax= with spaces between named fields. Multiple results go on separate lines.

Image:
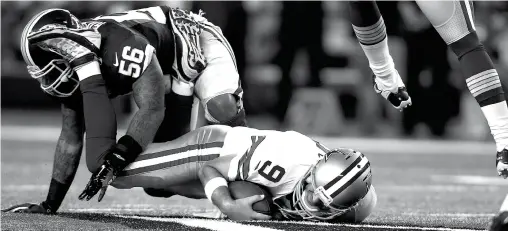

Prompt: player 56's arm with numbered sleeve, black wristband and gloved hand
xmin=79 ymin=38 xmax=164 ymax=201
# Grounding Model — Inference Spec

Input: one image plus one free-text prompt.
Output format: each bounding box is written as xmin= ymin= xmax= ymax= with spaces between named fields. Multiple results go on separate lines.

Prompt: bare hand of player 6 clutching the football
xmin=222 ymin=195 xmax=271 ymax=221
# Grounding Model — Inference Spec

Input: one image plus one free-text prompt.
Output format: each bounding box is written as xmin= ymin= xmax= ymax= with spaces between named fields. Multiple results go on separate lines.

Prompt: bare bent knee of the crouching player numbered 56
xmin=205 ymin=94 xmax=246 ymax=127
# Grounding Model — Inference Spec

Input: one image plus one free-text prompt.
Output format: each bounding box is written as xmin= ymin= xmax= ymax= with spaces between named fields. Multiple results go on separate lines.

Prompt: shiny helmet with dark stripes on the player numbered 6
xmin=280 ymin=146 xmax=372 ymax=221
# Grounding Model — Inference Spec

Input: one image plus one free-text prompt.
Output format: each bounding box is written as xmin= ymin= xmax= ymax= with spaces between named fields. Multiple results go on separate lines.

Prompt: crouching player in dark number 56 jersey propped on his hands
xmin=7 ymin=6 xmax=245 ymax=213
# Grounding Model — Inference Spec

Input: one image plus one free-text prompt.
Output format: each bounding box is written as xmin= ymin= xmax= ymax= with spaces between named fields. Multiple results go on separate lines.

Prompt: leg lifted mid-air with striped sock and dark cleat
xmin=349 ymin=1 xmax=411 ymax=110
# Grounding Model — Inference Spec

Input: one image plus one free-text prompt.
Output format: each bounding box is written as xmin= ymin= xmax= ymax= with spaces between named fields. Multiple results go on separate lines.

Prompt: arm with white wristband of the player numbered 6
xmin=198 ymin=155 xmax=271 ymax=220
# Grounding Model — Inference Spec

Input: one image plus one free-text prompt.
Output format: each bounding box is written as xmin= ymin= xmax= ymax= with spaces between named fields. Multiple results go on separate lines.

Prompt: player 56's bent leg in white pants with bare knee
xmin=195 ymin=24 xmax=247 ymax=127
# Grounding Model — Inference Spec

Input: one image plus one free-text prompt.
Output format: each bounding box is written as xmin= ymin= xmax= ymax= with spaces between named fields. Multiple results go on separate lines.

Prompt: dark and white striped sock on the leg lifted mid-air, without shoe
xmin=349 ymin=1 xmax=398 ymax=92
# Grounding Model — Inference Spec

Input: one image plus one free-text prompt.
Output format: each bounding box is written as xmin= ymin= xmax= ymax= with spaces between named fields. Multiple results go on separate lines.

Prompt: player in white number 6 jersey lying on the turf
xmin=3 ymin=125 xmax=377 ymax=222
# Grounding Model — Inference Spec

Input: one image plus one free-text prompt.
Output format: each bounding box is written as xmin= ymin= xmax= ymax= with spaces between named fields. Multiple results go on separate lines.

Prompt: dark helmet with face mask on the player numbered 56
xmin=20 ymin=9 xmax=80 ymax=97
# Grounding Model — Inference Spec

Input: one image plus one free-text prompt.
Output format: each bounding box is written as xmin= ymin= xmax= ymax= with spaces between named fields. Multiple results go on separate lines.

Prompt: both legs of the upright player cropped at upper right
xmin=349 ymin=0 xmax=508 ymax=178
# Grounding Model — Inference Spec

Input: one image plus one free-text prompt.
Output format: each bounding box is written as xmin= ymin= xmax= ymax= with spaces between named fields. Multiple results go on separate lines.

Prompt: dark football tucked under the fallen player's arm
xmin=228 ymin=181 xmax=276 ymax=216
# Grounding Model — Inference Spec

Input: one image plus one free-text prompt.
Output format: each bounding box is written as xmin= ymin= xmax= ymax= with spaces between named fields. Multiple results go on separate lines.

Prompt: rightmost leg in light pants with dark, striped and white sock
xmin=416 ymin=0 xmax=508 ymax=177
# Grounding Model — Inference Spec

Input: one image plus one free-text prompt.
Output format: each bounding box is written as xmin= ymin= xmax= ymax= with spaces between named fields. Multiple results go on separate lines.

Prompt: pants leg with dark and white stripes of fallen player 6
xmin=111 ymin=125 xmax=231 ymax=191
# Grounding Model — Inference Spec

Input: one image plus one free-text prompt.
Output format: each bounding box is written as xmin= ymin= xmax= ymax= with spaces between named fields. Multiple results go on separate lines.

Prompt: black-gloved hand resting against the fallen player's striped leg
xmin=79 ymin=161 xmax=116 ymax=202
